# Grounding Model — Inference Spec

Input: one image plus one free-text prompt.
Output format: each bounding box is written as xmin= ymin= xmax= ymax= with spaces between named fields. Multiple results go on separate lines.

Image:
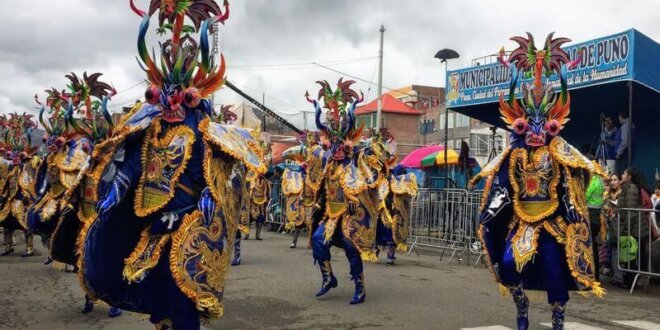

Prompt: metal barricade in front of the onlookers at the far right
xmin=610 ymin=209 xmax=660 ymax=294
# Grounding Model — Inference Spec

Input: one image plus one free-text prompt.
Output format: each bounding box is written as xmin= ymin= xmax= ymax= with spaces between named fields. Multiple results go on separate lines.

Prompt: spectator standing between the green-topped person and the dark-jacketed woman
xmin=602 ymin=174 xmax=624 ymax=286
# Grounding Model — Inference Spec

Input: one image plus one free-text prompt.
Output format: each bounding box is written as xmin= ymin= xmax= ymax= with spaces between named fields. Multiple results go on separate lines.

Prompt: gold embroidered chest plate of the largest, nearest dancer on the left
xmin=135 ymin=120 xmax=195 ymax=217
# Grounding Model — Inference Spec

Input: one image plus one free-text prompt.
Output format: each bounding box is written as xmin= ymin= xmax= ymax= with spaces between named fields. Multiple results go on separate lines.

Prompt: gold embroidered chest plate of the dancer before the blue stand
xmin=509 ymin=147 xmax=560 ymax=222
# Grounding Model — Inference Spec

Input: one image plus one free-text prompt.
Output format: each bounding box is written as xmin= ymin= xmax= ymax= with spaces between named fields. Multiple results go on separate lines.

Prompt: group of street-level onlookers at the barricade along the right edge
xmin=586 ymin=168 xmax=660 ymax=288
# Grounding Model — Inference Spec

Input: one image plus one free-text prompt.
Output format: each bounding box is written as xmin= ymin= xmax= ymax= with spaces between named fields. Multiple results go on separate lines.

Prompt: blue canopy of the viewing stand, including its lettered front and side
xmin=446 ymin=29 xmax=660 ymax=179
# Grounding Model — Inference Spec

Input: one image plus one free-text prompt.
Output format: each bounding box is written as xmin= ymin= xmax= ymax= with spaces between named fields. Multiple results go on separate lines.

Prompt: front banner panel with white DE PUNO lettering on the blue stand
xmin=445 ymin=30 xmax=634 ymax=107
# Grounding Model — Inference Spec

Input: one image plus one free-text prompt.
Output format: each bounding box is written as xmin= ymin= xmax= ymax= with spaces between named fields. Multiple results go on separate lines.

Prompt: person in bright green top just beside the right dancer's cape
xmin=587 ymin=171 xmax=607 ymax=281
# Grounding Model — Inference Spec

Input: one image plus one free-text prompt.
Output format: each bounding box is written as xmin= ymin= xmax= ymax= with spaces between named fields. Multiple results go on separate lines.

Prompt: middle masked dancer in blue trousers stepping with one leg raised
xmin=307 ymin=79 xmax=412 ymax=304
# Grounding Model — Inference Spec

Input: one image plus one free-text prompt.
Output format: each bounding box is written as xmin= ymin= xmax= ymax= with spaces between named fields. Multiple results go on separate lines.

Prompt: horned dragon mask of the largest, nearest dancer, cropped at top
xmin=130 ymin=0 xmax=229 ymax=122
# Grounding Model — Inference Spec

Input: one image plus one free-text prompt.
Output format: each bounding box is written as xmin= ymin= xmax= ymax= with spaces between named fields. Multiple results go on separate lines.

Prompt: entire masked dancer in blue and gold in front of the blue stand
xmin=472 ymin=33 xmax=604 ymax=329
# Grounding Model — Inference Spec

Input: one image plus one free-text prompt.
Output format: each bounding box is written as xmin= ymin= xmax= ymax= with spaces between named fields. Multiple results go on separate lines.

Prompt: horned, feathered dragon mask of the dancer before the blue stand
xmin=498 ymin=33 xmax=580 ymax=146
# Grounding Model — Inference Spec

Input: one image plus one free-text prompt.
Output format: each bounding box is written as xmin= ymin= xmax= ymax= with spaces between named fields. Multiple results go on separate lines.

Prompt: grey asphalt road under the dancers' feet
xmin=0 ymin=233 xmax=660 ymax=330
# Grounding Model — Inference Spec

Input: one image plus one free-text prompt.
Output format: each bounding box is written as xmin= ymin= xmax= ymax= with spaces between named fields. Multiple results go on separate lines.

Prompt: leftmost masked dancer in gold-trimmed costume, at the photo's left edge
xmin=0 ymin=113 xmax=41 ymax=257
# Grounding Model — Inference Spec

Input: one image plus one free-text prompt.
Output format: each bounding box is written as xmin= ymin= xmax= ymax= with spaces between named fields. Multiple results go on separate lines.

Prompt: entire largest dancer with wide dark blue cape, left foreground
xmin=79 ymin=0 xmax=266 ymax=330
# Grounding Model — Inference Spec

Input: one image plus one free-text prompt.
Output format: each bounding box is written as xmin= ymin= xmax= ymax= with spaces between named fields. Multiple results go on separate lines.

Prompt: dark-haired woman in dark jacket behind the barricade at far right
xmin=619 ymin=168 xmax=651 ymax=287
